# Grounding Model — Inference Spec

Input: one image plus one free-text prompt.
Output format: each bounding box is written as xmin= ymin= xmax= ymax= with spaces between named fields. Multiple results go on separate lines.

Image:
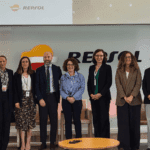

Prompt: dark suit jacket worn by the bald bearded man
xmin=36 ymin=64 xmax=62 ymax=103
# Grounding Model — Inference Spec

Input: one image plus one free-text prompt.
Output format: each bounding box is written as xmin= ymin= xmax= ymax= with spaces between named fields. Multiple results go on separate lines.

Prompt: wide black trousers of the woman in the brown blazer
xmin=117 ymin=103 xmax=141 ymax=150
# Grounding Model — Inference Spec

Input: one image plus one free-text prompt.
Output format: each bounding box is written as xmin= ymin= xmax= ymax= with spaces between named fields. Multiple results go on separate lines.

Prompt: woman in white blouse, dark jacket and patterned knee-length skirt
xmin=14 ymin=57 xmax=36 ymax=150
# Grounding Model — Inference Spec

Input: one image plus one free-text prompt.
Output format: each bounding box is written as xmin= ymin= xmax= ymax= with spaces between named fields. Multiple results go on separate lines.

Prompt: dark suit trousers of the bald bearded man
xmin=39 ymin=94 xmax=58 ymax=145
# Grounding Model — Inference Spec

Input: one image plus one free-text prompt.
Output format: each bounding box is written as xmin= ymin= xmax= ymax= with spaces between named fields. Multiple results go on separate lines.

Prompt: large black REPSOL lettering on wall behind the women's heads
xmin=68 ymin=51 xmax=142 ymax=63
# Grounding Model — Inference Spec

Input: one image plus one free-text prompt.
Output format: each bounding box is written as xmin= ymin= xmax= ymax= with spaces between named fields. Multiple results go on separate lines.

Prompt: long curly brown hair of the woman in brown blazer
xmin=118 ymin=51 xmax=139 ymax=72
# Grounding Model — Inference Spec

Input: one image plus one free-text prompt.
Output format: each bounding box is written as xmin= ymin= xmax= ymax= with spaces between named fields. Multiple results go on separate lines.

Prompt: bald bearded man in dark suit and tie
xmin=36 ymin=52 xmax=62 ymax=150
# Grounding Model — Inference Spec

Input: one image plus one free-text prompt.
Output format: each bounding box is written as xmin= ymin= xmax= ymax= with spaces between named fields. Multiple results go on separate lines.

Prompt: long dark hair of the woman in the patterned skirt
xmin=16 ymin=56 xmax=35 ymax=74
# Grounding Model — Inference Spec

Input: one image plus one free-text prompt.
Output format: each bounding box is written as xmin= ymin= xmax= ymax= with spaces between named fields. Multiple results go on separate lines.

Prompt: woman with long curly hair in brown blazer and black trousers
xmin=115 ymin=51 xmax=142 ymax=150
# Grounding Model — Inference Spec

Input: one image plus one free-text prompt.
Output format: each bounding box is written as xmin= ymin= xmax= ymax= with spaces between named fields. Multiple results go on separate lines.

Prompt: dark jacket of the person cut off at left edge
xmin=0 ymin=69 xmax=14 ymax=112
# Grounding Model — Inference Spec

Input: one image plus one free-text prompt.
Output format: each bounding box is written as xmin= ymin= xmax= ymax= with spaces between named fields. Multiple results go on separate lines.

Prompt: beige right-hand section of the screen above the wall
xmin=72 ymin=0 xmax=150 ymax=24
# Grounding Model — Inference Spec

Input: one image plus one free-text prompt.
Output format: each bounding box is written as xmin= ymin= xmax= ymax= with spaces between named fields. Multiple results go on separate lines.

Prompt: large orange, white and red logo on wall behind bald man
xmin=21 ymin=44 xmax=56 ymax=70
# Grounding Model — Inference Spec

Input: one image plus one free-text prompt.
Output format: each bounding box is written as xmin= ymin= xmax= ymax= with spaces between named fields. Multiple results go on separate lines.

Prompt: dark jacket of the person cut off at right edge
xmin=142 ymin=68 xmax=150 ymax=104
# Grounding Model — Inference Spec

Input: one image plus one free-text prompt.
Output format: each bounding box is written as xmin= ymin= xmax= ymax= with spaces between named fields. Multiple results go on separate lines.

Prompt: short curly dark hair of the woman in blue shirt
xmin=63 ymin=57 xmax=79 ymax=71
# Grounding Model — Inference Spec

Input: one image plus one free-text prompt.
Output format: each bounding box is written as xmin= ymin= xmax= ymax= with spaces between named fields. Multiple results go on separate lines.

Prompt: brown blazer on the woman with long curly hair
xmin=115 ymin=69 xmax=142 ymax=106
